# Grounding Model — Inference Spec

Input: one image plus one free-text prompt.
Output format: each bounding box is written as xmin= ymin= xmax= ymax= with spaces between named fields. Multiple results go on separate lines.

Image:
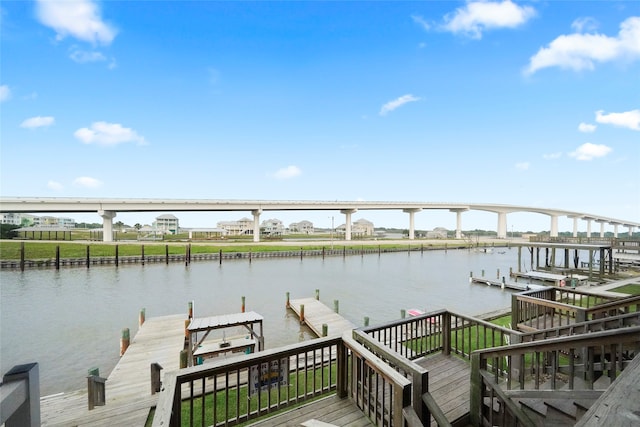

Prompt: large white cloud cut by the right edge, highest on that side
xmin=525 ymin=17 xmax=640 ymax=74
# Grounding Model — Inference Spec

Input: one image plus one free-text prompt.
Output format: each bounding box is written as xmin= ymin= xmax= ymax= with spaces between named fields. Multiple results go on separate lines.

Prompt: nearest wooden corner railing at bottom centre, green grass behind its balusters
xmin=153 ymin=332 xmax=420 ymax=427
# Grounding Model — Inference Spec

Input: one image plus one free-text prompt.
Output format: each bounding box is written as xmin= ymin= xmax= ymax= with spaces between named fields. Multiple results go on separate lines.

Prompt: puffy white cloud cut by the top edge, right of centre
xmin=444 ymin=0 xmax=536 ymax=39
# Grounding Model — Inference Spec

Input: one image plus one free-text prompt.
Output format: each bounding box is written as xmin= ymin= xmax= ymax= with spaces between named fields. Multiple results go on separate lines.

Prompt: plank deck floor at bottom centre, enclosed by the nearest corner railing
xmin=249 ymin=396 xmax=373 ymax=427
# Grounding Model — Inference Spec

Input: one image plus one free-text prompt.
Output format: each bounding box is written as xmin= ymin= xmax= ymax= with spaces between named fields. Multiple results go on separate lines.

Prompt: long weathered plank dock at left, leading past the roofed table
xmin=40 ymin=315 xmax=187 ymax=426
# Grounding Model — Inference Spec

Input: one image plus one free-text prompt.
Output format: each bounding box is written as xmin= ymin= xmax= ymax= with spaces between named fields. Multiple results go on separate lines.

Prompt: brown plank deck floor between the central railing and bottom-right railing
xmin=416 ymin=353 xmax=471 ymax=425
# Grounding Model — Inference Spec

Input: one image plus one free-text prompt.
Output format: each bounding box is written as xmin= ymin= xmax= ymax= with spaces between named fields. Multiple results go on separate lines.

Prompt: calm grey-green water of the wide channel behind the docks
xmin=0 ymin=249 xmax=517 ymax=396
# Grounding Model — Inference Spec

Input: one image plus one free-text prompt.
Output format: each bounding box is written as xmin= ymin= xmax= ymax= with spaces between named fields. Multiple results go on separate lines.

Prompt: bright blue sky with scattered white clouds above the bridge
xmin=0 ymin=0 xmax=640 ymax=231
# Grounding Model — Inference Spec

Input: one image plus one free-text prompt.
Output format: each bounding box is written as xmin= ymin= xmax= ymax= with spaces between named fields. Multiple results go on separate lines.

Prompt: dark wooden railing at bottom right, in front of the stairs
xmin=470 ymin=326 xmax=640 ymax=425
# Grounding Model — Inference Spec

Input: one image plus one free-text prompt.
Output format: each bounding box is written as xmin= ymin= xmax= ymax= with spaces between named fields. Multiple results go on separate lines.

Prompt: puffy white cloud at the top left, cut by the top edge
xmin=36 ymin=0 xmax=117 ymax=45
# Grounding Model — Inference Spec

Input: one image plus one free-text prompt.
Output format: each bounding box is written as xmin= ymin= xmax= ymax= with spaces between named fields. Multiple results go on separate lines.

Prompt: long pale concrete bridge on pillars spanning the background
xmin=0 ymin=197 xmax=640 ymax=242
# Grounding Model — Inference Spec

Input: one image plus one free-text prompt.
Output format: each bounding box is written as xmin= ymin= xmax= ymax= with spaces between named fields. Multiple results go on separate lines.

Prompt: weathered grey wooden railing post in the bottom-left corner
xmin=0 ymin=363 xmax=40 ymax=427
